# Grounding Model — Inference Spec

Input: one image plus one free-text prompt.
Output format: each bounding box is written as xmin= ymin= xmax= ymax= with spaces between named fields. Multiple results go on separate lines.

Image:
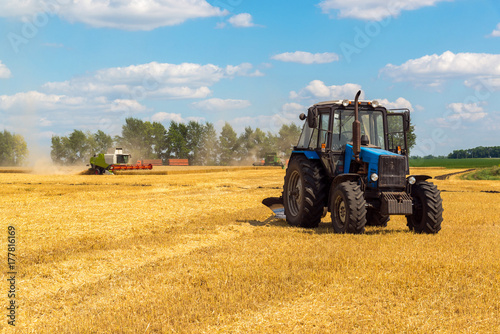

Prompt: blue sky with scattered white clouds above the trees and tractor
xmin=0 ymin=0 xmax=500 ymax=156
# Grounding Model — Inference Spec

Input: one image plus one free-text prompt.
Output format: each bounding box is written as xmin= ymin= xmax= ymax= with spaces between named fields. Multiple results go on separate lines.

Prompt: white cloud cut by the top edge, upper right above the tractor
xmin=319 ymin=0 xmax=454 ymax=21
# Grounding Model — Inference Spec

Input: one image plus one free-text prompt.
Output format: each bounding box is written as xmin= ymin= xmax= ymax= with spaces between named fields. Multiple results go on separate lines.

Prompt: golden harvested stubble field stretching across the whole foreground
xmin=0 ymin=168 xmax=500 ymax=333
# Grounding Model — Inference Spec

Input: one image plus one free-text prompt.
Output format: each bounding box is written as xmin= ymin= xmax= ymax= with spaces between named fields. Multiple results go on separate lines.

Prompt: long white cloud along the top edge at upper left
xmin=0 ymin=0 xmax=228 ymax=30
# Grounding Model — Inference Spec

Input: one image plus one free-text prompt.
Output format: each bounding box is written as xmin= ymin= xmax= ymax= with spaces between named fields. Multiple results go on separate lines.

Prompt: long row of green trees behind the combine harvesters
xmin=51 ymin=117 xmax=301 ymax=166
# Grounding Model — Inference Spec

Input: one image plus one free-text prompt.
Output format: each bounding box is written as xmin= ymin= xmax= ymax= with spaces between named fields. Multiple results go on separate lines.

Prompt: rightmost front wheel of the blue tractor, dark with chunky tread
xmin=406 ymin=181 xmax=443 ymax=234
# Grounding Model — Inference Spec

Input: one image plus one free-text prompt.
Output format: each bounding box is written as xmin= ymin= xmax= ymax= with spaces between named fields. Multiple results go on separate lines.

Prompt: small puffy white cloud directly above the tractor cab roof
xmin=290 ymin=80 xmax=363 ymax=102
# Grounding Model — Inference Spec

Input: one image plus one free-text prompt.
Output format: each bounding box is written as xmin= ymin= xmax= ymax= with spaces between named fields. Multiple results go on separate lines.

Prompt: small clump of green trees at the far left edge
xmin=0 ymin=130 xmax=28 ymax=166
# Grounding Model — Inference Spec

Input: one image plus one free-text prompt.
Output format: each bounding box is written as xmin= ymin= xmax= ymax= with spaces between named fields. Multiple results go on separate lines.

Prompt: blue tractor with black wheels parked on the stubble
xmin=263 ymin=91 xmax=443 ymax=233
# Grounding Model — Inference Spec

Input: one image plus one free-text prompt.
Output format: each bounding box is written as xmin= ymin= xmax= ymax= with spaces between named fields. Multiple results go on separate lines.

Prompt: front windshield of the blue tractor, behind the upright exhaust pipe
xmin=332 ymin=109 xmax=385 ymax=150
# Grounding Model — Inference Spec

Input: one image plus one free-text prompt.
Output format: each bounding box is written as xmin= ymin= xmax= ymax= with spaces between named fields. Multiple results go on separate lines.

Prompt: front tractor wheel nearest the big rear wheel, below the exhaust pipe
xmin=330 ymin=181 xmax=366 ymax=234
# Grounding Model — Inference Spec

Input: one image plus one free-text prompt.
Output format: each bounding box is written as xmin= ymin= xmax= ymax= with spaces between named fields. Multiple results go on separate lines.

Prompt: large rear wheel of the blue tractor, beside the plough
xmin=283 ymin=156 xmax=326 ymax=228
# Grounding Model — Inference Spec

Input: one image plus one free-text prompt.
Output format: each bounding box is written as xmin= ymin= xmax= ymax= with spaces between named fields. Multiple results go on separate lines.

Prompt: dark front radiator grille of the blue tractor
xmin=378 ymin=155 xmax=406 ymax=188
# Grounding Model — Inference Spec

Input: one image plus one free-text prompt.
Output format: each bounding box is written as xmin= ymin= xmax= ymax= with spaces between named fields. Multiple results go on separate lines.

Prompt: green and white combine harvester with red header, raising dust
xmin=89 ymin=147 xmax=153 ymax=175
